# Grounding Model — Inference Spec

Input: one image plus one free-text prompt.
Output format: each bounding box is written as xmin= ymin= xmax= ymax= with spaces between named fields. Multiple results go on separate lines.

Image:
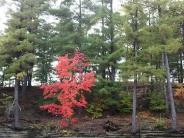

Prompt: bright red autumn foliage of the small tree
xmin=40 ymin=52 xmax=96 ymax=127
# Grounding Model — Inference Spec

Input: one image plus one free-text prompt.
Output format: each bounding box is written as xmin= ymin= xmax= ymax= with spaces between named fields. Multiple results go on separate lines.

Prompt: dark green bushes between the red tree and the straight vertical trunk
xmin=87 ymin=79 xmax=132 ymax=116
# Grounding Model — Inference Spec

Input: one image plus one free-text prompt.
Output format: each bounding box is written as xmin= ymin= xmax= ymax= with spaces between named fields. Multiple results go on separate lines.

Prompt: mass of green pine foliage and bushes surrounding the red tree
xmin=0 ymin=0 xmax=184 ymax=127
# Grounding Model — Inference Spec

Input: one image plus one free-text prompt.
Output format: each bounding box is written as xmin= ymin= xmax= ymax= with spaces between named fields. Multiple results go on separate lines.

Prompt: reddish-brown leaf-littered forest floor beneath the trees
xmin=0 ymin=88 xmax=184 ymax=136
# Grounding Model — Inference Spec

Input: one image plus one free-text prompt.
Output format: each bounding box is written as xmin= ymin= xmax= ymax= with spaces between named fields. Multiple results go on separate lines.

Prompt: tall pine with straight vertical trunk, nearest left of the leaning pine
xmin=122 ymin=0 xmax=149 ymax=133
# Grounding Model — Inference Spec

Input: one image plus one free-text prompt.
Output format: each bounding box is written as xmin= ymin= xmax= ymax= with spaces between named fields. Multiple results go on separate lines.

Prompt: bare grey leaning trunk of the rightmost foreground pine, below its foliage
xmin=164 ymin=53 xmax=176 ymax=131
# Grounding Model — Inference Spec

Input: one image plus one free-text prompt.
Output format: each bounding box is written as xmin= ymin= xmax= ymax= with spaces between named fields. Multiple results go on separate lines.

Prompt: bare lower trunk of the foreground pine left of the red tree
xmin=14 ymin=79 xmax=21 ymax=129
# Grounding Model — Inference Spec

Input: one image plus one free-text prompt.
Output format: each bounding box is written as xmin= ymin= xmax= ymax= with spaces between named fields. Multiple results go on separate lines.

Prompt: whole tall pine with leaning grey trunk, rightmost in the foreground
xmin=151 ymin=0 xmax=180 ymax=131
